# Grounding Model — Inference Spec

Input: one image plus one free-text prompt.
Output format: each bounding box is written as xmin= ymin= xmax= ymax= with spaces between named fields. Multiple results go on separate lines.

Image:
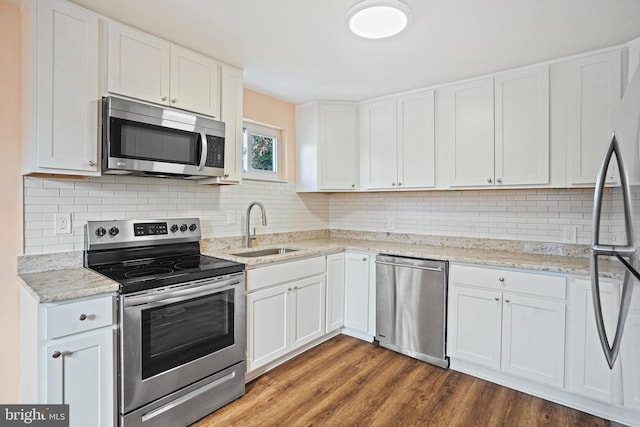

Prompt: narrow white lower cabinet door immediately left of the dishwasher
xmin=344 ymin=251 xmax=376 ymax=341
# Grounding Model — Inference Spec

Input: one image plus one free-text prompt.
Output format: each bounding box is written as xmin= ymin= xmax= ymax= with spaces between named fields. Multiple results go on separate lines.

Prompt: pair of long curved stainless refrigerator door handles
xmin=590 ymin=133 xmax=640 ymax=369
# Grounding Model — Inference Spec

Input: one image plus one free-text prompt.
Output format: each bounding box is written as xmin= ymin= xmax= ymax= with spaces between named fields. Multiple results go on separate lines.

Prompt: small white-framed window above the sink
xmin=242 ymin=123 xmax=280 ymax=180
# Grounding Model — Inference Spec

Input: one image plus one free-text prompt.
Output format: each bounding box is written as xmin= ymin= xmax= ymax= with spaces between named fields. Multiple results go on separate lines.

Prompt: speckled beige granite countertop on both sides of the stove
xmin=18 ymin=231 xmax=600 ymax=303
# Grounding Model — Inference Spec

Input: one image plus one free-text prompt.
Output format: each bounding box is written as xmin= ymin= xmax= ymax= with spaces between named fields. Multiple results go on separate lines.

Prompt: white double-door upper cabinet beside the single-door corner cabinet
xmin=360 ymin=90 xmax=435 ymax=190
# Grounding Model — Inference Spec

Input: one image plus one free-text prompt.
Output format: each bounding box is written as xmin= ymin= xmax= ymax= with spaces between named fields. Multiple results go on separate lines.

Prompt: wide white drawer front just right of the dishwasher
xmin=449 ymin=265 xmax=567 ymax=299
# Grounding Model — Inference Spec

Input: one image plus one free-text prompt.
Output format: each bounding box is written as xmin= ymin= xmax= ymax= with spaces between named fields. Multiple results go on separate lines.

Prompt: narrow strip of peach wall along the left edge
xmin=0 ymin=0 xmax=22 ymax=403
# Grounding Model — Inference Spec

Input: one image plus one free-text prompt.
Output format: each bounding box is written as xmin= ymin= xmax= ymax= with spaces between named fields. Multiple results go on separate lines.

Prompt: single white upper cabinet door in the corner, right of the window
xmin=318 ymin=104 xmax=358 ymax=190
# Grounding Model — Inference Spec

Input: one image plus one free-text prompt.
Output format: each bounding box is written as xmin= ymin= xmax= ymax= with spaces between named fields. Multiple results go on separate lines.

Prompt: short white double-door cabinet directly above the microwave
xmin=107 ymin=21 xmax=220 ymax=119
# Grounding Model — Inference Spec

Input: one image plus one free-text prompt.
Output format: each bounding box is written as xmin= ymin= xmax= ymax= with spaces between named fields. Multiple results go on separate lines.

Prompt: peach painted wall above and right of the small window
xmin=243 ymin=89 xmax=296 ymax=182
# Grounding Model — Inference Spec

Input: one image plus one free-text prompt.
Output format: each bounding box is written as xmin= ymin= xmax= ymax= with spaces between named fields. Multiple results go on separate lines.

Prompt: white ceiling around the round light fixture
xmin=13 ymin=0 xmax=640 ymax=103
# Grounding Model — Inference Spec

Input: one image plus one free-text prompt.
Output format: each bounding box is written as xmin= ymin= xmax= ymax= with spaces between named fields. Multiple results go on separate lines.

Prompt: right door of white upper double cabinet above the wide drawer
xmin=495 ymin=65 xmax=549 ymax=185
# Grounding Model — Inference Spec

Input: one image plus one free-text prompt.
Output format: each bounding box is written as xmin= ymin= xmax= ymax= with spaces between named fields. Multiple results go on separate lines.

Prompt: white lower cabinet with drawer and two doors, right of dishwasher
xmin=447 ymin=265 xmax=565 ymax=387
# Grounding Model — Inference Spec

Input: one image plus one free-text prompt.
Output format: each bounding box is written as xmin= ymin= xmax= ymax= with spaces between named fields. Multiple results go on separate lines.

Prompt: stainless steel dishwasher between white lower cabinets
xmin=376 ymin=255 xmax=449 ymax=368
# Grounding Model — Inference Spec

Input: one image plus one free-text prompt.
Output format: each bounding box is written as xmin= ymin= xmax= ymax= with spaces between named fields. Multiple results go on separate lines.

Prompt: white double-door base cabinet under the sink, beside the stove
xmin=247 ymin=257 xmax=325 ymax=371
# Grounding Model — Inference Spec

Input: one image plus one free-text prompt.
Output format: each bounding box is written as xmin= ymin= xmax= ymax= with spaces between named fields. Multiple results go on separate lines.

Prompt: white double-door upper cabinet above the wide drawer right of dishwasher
xmin=441 ymin=65 xmax=549 ymax=187
